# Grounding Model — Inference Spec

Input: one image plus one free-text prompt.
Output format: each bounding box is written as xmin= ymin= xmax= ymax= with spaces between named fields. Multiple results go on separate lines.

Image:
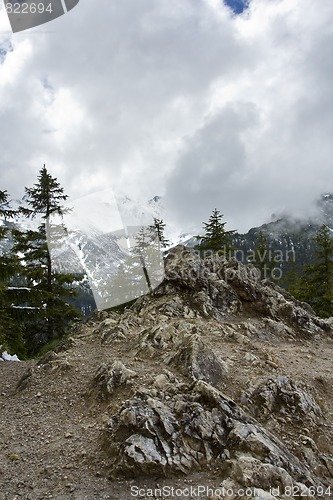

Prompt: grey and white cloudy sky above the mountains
xmin=0 ymin=0 xmax=333 ymax=231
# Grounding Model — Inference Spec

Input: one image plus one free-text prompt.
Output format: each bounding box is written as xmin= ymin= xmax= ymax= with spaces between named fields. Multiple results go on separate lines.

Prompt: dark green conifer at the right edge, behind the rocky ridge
xmin=293 ymin=225 xmax=333 ymax=318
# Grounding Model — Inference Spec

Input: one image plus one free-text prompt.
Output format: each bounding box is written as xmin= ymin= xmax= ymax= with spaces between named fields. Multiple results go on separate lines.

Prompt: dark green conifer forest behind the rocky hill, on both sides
xmin=0 ymin=169 xmax=333 ymax=359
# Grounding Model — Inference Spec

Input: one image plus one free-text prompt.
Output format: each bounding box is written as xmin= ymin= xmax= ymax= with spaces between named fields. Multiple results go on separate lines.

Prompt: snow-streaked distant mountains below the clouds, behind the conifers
xmin=2 ymin=190 xmax=333 ymax=308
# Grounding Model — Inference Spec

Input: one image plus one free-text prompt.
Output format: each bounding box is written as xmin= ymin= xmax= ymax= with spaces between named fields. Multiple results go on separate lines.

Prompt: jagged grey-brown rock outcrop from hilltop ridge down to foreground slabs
xmin=97 ymin=247 xmax=331 ymax=490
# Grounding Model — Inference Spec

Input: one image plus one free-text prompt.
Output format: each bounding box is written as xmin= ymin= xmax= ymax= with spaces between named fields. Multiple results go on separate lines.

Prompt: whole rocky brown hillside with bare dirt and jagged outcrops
xmin=0 ymin=246 xmax=333 ymax=500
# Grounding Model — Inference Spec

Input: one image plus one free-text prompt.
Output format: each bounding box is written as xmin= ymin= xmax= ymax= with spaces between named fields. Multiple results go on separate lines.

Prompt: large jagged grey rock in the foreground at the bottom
xmin=104 ymin=380 xmax=322 ymax=486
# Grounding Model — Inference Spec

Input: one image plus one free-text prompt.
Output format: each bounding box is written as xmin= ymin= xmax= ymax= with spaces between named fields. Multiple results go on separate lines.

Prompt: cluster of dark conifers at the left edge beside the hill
xmin=0 ymin=166 xmax=81 ymax=358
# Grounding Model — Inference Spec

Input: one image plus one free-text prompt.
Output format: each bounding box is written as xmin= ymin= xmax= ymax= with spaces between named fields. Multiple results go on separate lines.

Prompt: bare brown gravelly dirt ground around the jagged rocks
xmin=0 ymin=314 xmax=333 ymax=500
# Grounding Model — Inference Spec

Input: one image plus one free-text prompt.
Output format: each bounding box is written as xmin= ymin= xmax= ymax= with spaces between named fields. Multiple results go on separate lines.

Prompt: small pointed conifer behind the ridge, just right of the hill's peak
xmin=196 ymin=208 xmax=235 ymax=257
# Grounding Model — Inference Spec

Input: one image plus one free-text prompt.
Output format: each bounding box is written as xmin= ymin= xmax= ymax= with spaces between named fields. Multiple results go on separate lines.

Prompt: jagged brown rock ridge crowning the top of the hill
xmin=157 ymin=246 xmax=332 ymax=336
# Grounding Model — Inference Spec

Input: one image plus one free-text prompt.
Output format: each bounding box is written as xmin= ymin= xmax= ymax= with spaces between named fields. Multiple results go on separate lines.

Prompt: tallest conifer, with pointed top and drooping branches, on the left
xmin=13 ymin=165 xmax=79 ymax=354
